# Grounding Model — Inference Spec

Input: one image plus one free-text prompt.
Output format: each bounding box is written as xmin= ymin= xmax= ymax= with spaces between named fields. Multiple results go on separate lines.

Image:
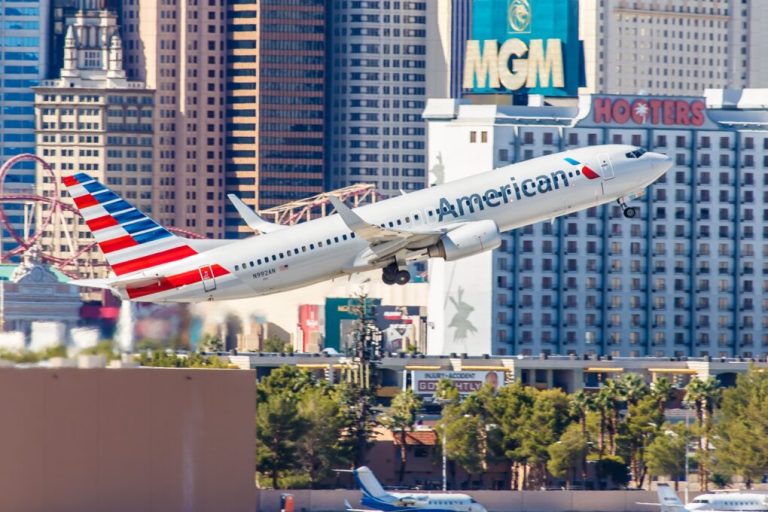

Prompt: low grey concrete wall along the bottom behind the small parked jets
xmin=257 ymin=490 xmax=658 ymax=512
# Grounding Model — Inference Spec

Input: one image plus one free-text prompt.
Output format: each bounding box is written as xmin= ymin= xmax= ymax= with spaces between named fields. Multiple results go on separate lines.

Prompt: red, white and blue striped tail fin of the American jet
xmin=63 ymin=173 xmax=197 ymax=276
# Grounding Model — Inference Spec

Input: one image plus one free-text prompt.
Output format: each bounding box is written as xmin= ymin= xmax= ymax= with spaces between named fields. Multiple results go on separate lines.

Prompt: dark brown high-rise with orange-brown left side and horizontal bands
xmin=224 ymin=0 xmax=326 ymax=236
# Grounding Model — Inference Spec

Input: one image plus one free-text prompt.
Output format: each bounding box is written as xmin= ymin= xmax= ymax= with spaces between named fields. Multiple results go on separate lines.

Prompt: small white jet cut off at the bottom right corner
xmin=644 ymin=483 xmax=768 ymax=512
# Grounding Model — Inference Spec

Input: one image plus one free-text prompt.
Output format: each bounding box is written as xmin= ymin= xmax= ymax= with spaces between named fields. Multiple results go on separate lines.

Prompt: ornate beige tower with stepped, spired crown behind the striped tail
xmin=35 ymin=0 xmax=155 ymax=275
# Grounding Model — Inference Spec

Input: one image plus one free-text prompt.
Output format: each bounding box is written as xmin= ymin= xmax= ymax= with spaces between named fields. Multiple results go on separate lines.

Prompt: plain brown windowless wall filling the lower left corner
xmin=0 ymin=368 xmax=255 ymax=512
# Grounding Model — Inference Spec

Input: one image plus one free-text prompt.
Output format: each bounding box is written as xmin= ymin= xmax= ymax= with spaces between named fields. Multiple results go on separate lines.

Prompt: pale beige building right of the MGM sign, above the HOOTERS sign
xmin=580 ymin=0 xmax=768 ymax=95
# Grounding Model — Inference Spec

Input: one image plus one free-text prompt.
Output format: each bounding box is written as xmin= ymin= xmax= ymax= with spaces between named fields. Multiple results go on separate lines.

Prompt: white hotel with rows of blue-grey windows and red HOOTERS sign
xmin=424 ymin=90 xmax=768 ymax=357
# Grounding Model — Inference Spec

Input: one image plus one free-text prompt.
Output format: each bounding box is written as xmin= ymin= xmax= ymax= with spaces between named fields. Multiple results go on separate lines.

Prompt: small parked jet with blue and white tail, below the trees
xmin=344 ymin=466 xmax=486 ymax=512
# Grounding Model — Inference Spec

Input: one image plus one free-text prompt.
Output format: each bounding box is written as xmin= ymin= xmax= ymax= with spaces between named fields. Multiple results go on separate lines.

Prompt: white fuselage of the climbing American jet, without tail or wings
xmin=123 ymin=145 xmax=669 ymax=302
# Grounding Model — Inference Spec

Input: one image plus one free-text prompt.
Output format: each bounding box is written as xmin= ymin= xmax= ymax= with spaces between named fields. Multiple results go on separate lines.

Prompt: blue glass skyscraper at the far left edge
xmin=0 ymin=0 xmax=50 ymax=252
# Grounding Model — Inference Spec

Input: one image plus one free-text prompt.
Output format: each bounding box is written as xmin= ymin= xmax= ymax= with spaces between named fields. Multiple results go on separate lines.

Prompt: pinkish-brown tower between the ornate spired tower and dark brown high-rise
xmin=121 ymin=0 xmax=226 ymax=238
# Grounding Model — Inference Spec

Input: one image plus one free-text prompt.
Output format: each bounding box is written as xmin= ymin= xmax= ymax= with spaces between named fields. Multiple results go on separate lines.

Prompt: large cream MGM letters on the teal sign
xmin=463 ymin=39 xmax=565 ymax=91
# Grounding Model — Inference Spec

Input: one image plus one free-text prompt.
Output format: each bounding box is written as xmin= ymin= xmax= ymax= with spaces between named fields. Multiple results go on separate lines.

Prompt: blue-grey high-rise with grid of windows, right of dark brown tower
xmin=328 ymin=1 xmax=436 ymax=195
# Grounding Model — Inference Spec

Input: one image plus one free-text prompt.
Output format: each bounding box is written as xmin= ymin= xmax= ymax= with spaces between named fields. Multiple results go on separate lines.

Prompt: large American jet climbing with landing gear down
xmin=62 ymin=145 xmax=672 ymax=302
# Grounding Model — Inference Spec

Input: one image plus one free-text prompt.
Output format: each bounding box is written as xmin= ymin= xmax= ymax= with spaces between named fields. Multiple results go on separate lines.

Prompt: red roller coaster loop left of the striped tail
xmin=0 ymin=153 xmax=202 ymax=276
